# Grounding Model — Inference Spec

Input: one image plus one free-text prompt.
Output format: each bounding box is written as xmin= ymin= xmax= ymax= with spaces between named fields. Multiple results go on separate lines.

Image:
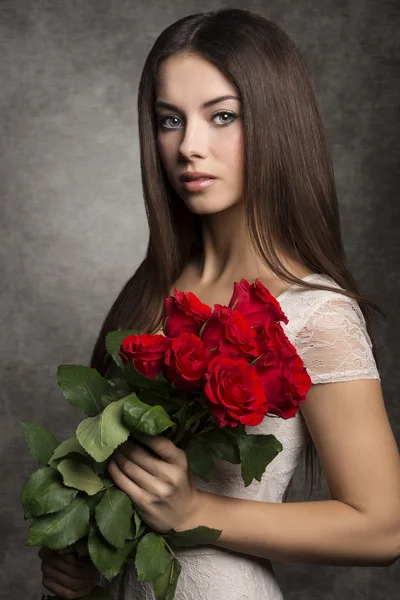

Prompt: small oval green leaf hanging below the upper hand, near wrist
xmin=135 ymin=533 xmax=170 ymax=581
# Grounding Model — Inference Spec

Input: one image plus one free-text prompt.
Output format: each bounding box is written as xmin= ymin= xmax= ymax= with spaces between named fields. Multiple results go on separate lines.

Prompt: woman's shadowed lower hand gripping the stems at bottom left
xmin=38 ymin=546 xmax=100 ymax=599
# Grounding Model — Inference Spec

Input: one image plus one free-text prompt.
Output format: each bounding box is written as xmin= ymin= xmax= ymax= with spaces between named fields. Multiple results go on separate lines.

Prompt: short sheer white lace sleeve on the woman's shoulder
xmin=294 ymin=294 xmax=381 ymax=384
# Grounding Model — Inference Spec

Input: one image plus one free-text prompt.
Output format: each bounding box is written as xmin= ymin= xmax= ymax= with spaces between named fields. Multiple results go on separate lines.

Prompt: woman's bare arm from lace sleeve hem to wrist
xmin=180 ymin=379 xmax=400 ymax=566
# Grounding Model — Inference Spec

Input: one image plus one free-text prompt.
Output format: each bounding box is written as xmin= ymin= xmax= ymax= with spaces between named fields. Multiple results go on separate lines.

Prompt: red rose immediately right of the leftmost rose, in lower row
xmin=165 ymin=333 xmax=211 ymax=391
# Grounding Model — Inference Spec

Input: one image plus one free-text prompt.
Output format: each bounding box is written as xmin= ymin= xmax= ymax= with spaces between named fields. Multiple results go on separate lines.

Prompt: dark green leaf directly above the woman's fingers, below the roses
xmin=123 ymin=393 xmax=176 ymax=435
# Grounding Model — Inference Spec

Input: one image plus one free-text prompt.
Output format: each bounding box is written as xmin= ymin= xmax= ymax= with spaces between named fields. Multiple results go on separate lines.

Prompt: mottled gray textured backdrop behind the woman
xmin=0 ymin=0 xmax=400 ymax=600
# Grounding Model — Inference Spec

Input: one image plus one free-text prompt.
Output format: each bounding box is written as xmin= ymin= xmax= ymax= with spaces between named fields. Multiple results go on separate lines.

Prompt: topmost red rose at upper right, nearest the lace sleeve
xmin=228 ymin=279 xmax=289 ymax=333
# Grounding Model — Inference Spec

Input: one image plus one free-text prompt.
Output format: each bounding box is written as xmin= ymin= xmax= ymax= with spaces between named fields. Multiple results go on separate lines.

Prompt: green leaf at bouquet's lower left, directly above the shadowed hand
xmin=27 ymin=496 xmax=89 ymax=550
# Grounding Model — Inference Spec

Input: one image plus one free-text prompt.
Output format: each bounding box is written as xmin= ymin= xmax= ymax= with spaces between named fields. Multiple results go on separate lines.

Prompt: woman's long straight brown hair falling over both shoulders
xmin=90 ymin=8 xmax=387 ymax=501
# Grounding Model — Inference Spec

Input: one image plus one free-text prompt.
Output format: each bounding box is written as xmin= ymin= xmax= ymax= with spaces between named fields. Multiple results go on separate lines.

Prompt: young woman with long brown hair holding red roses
xmin=41 ymin=9 xmax=400 ymax=600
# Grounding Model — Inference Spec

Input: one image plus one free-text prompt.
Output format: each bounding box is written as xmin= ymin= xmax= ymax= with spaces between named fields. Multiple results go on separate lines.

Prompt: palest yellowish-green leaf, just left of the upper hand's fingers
xmin=76 ymin=398 xmax=130 ymax=462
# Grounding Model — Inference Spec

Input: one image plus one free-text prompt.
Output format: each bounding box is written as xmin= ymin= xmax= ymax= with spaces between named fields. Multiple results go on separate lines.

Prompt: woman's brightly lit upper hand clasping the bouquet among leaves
xmin=108 ymin=433 xmax=200 ymax=533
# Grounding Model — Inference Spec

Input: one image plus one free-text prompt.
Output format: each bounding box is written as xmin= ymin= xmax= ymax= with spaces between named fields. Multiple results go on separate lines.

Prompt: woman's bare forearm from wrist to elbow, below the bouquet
xmin=180 ymin=490 xmax=398 ymax=566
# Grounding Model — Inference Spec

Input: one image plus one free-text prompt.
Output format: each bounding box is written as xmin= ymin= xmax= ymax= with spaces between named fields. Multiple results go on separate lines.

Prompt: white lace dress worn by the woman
xmin=103 ymin=273 xmax=381 ymax=600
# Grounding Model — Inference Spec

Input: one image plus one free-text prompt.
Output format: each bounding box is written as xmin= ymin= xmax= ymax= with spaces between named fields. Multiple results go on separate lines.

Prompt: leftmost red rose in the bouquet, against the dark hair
xmin=118 ymin=333 xmax=171 ymax=379
